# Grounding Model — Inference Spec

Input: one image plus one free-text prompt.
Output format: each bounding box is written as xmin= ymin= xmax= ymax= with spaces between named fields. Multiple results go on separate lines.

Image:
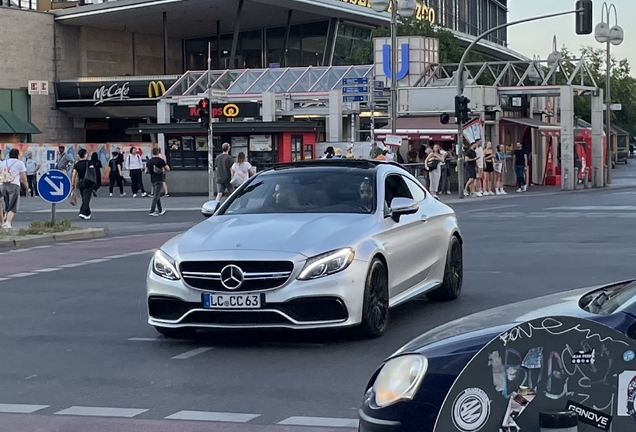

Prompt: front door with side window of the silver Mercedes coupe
xmin=377 ymin=172 xmax=423 ymax=297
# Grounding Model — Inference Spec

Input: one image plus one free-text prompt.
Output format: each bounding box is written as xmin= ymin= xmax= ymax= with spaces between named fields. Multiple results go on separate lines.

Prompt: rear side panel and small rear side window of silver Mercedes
xmin=404 ymin=176 xmax=448 ymax=283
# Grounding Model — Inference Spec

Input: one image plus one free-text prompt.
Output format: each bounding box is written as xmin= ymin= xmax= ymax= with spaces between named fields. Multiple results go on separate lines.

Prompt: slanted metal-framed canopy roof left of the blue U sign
xmin=163 ymin=65 xmax=373 ymax=98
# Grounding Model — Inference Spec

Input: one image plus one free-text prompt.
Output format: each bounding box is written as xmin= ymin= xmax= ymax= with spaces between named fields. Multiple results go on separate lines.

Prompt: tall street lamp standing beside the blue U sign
xmin=370 ymin=0 xmax=417 ymax=135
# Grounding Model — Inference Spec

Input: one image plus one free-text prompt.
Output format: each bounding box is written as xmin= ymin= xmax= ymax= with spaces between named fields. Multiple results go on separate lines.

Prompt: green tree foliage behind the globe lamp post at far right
xmin=557 ymin=46 xmax=636 ymax=136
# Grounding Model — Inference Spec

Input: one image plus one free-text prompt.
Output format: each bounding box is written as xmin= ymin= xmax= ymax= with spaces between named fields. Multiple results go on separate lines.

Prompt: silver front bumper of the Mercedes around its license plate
xmin=146 ymin=260 xmax=368 ymax=329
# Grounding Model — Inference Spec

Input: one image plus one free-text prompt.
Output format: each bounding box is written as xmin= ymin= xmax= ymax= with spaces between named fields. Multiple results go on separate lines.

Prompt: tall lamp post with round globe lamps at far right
xmin=594 ymin=2 xmax=625 ymax=184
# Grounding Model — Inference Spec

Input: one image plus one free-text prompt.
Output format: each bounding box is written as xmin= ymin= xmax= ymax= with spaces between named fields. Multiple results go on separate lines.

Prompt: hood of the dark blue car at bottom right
xmin=394 ymin=286 xmax=602 ymax=356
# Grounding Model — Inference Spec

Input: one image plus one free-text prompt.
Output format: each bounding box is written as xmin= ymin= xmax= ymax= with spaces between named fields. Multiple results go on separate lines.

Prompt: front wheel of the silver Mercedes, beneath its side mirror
xmin=358 ymin=257 xmax=389 ymax=338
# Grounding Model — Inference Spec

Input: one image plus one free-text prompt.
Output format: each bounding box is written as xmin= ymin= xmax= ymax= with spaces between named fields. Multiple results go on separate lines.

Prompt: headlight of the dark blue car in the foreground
xmin=373 ymin=354 xmax=428 ymax=408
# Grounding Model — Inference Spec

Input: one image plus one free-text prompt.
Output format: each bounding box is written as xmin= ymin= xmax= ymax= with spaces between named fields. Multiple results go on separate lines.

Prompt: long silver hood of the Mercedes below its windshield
xmin=166 ymin=214 xmax=377 ymax=257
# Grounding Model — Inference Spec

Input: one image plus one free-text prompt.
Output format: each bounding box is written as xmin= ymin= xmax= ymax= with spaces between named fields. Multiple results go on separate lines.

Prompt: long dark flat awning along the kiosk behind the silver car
xmin=126 ymin=121 xmax=324 ymax=135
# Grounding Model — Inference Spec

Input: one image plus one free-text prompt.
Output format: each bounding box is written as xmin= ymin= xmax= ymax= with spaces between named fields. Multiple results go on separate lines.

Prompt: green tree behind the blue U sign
xmin=345 ymin=18 xmax=484 ymax=64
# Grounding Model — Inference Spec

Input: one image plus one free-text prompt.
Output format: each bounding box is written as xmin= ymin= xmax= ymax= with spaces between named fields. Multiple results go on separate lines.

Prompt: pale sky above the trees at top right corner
xmin=508 ymin=0 xmax=636 ymax=66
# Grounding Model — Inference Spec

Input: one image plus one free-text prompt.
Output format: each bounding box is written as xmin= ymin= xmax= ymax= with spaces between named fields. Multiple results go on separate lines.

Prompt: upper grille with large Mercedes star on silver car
xmin=179 ymin=261 xmax=294 ymax=292
